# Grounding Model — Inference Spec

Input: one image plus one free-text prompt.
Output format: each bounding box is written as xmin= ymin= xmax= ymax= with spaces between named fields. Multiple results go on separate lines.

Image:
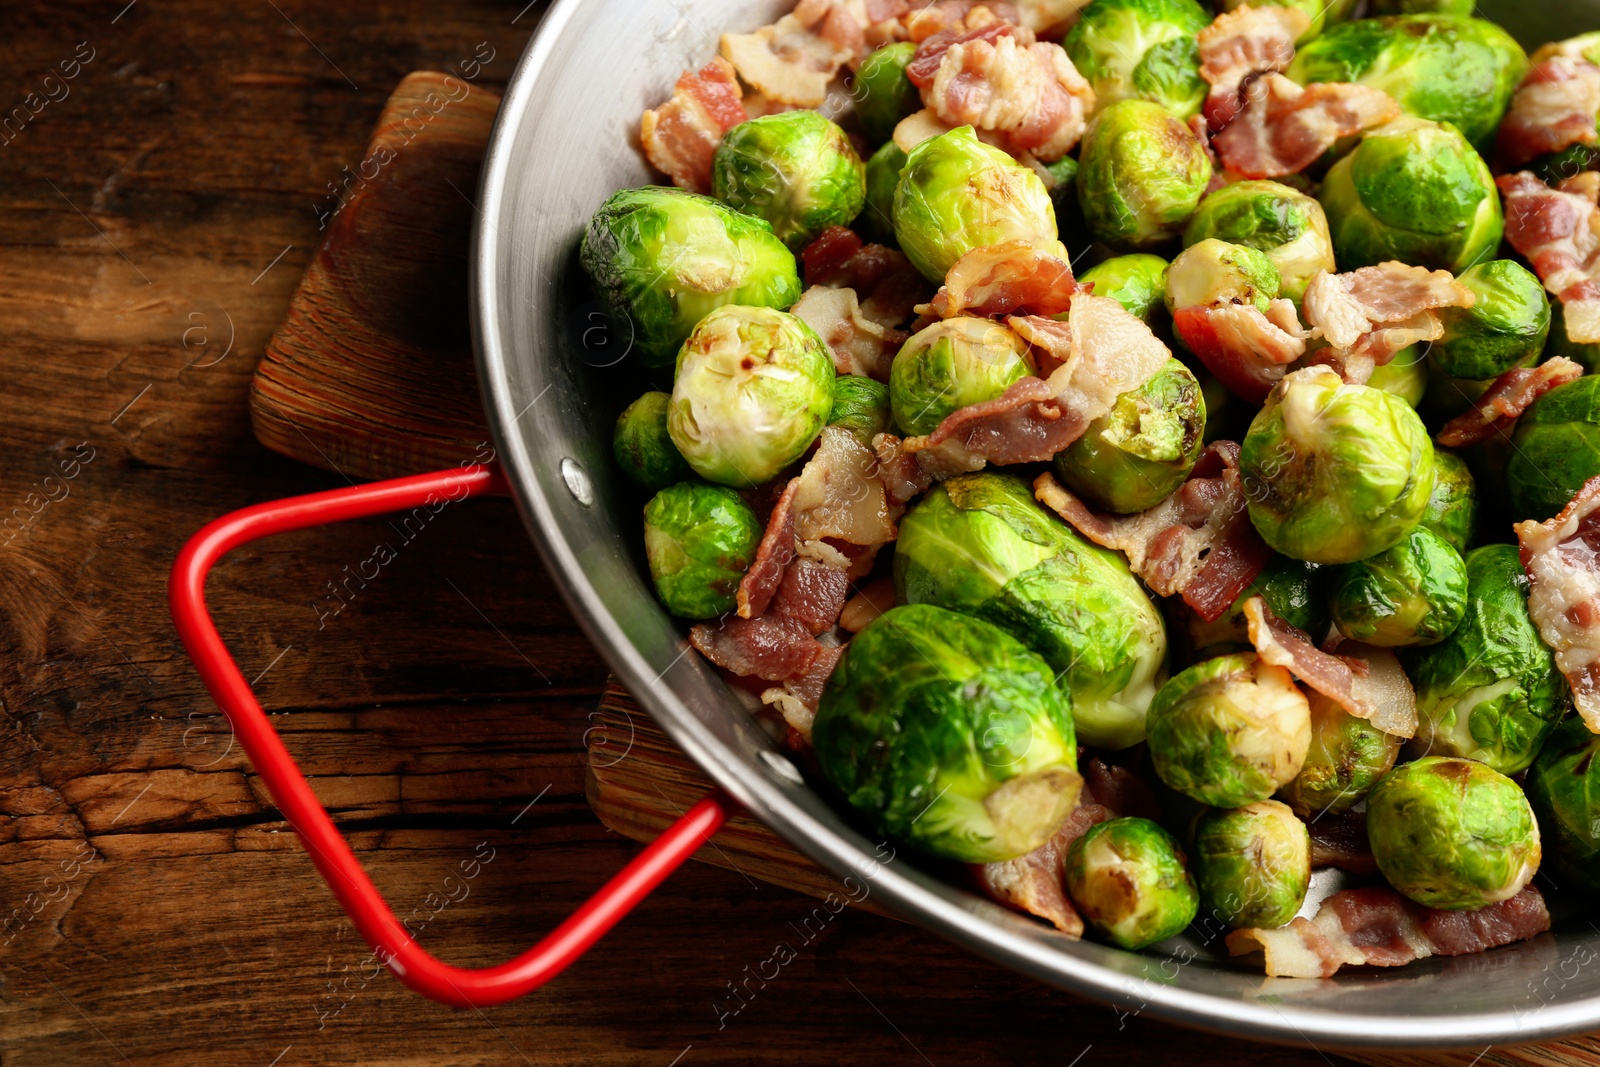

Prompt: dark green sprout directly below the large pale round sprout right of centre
xmin=1330 ymin=525 xmax=1467 ymax=648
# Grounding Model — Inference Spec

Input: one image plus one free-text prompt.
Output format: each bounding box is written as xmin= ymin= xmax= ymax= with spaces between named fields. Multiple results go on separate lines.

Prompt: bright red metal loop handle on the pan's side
xmin=168 ymin=466 xmax=736 ymax=1008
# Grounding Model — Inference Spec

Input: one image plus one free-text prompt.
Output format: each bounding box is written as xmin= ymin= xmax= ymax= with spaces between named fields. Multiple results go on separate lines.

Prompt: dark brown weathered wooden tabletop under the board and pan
xmin=0 ymin=0 xmax=1369 ymax=1067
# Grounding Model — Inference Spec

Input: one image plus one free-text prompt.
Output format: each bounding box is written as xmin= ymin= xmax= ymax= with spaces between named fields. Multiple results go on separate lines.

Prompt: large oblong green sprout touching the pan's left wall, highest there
xmin=579 ymin=186 xmax=800 ymax=366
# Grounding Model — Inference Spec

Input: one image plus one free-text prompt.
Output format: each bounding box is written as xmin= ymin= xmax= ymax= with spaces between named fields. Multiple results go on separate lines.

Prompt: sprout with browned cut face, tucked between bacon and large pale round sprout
xmin=1056 ymin=358 xmax=1205 ymax=515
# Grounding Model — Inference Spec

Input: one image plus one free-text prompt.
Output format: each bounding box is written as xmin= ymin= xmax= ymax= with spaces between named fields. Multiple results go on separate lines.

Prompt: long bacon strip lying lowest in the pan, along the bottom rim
xmin=1227 ymin=886 xmax=1550 ymax=977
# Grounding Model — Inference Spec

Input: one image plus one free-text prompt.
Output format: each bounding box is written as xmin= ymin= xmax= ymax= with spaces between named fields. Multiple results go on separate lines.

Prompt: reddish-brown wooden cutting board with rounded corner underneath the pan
xmin=250 ymin=72 xmax=1600 ymax=1067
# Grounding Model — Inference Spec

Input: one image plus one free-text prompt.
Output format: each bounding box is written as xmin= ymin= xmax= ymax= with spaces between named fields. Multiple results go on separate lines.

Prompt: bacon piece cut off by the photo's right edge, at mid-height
xmin=1514 ymin=477 xmax=1600 ymax=734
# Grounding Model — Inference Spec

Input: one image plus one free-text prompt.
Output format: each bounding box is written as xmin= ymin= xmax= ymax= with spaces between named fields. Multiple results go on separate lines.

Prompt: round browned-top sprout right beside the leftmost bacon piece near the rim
xmin=710 ymin=110 xmax=867 ymax=251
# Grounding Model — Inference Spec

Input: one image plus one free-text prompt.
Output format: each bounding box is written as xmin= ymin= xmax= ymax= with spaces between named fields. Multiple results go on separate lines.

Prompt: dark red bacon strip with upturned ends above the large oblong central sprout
xmin=1034 ymin=442 xmax=1272 ymax=622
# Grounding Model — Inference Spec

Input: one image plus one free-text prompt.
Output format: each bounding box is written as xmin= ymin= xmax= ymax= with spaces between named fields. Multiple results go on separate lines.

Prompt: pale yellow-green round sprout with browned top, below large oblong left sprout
xmin=667 ymin=304 xmax=835 ymax=488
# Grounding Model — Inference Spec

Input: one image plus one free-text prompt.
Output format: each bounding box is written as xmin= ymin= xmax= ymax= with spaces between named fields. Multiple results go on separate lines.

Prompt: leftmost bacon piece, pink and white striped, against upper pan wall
xmin=638 ymin=56 xmax=747 ymax=192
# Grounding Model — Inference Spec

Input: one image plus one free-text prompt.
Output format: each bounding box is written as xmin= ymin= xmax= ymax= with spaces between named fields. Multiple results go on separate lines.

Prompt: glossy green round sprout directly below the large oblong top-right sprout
xmin=1318 ymin=115 xmax=1506 ymax=274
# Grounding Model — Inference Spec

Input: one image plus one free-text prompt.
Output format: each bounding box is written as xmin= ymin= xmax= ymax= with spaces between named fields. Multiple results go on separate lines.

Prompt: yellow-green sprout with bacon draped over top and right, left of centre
xmin=890 ymin=317 xmax=1034 ymax=437
